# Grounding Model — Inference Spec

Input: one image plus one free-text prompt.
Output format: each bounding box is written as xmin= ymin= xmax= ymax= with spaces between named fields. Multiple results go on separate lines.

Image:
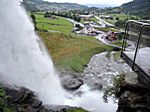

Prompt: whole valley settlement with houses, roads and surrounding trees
xmin=41 ymin=10 xmax=132 ymax=43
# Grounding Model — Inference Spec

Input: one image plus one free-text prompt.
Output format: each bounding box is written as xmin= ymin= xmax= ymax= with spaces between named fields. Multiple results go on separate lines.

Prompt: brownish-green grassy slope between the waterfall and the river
xmin=39 ymin=32 xmax=112 ymax=72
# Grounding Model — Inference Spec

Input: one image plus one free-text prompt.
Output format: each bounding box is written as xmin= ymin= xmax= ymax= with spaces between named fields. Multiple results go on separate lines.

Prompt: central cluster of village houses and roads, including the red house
xmin=72 ymin=15 xmax=123 ymax=42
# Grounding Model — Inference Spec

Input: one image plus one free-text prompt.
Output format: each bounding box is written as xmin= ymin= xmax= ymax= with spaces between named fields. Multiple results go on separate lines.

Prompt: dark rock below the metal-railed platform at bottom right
xmin=118 ymin=91 xmax=150 ymax=112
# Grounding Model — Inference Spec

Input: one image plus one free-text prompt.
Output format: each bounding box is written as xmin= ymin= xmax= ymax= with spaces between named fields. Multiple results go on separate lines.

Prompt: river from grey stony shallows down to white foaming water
xmin=62 ymin=52 xmax=130 ymax=112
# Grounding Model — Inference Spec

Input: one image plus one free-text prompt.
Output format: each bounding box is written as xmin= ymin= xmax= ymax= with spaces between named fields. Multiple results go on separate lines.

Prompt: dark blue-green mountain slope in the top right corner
xmin=121 ymin=0 xmax=150 ymax=16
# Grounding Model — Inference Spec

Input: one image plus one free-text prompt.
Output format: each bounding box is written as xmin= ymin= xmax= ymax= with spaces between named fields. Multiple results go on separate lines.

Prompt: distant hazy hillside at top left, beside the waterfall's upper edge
xmin=22 ymin=0 xmax=88 ymax=11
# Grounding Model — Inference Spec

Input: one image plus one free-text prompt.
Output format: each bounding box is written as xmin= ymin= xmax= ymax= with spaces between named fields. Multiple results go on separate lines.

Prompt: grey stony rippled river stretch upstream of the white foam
xmin=82 ymin=52 xmax=130 ymax=88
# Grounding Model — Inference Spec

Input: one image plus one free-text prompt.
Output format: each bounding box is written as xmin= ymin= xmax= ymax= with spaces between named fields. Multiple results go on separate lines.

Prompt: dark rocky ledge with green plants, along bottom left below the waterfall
xmin=0 ymin=87 xmax=87 ymax=112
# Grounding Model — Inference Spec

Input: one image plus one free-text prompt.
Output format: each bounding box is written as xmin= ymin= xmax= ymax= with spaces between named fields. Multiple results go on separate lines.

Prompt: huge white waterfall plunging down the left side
xmin=0 ymin=0 xmax=64 ymax=104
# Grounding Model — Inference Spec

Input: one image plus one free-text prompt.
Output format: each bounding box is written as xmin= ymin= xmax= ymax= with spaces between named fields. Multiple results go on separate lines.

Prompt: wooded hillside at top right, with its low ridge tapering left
xmin=99 ymin=0 xmax=150 ymax=19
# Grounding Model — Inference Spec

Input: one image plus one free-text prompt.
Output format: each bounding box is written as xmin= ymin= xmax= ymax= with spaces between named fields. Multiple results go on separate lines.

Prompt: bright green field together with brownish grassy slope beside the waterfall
xmin=35 ymin=13 xmax=112 ymax=72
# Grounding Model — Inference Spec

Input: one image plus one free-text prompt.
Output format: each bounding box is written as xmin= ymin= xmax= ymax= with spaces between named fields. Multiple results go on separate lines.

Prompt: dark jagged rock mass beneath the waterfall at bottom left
xmin=5 ymin=88 xmax=45 ymax=112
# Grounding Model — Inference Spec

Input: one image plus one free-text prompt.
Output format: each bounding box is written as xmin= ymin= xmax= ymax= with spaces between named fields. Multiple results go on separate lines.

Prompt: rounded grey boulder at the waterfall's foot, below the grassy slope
xmin=62 ymin=77 xmax=83 ymax=90
